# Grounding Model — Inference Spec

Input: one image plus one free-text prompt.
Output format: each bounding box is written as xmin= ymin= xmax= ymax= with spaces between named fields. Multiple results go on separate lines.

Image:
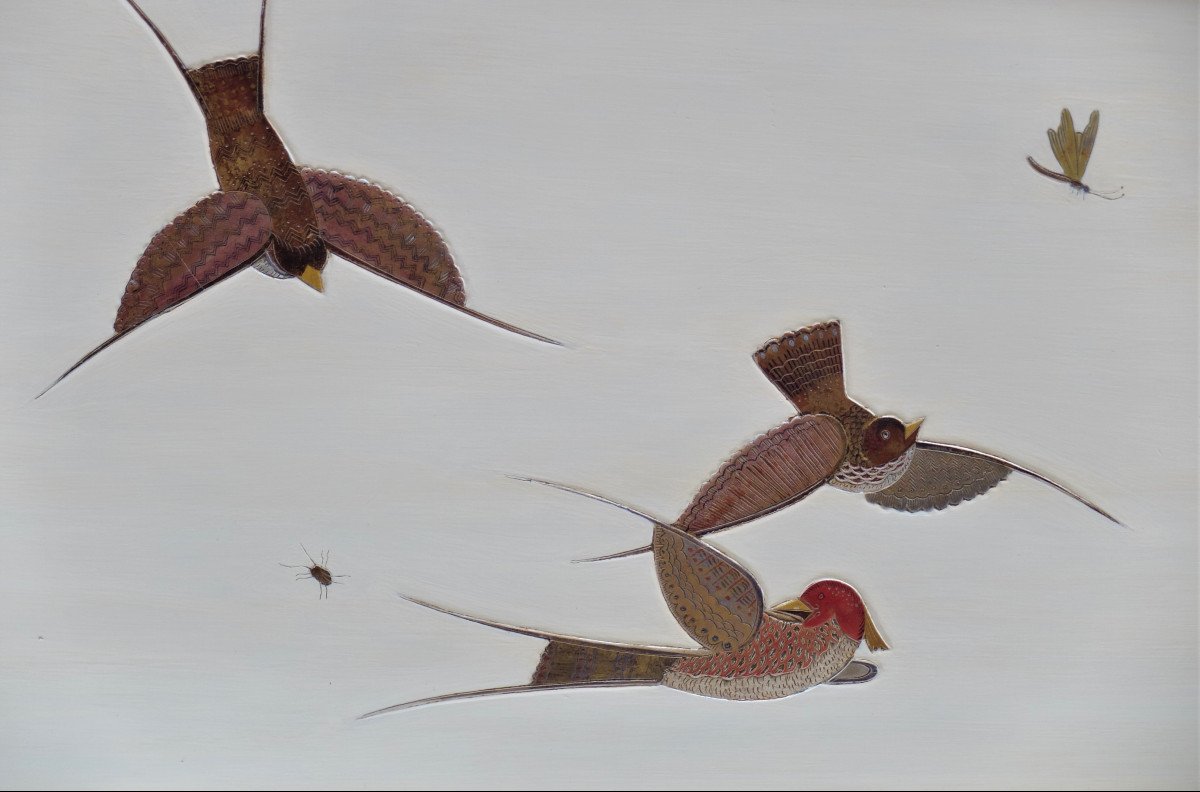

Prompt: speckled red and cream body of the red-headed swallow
xmin=662 ymin=616 xmax=859 ymax=701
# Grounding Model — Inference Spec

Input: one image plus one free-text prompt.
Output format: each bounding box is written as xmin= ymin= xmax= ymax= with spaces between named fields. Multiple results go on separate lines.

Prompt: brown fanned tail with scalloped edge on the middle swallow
xmin=754 ymin=320 xmax=853 ymax=415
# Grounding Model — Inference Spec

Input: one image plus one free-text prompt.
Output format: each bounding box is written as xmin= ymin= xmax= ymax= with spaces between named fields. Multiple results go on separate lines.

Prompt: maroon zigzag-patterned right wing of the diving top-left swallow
xmin=301 ymin=168 xmax=467 ymax=306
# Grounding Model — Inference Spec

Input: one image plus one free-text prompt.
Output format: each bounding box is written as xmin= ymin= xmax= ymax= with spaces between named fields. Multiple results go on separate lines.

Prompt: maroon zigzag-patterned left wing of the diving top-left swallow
xmin=113 ymin=192 xmax=271 ymax=335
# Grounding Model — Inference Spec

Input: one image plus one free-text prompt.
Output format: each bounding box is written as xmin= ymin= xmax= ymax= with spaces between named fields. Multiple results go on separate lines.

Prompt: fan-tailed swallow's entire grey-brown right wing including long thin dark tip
xmin=866 ymin=440 xmax=1122 ymax=526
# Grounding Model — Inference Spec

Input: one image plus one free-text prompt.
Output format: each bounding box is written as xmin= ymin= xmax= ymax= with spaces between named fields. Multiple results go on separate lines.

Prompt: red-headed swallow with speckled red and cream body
xmin=362 ymin=523 xmax=888 ymax=718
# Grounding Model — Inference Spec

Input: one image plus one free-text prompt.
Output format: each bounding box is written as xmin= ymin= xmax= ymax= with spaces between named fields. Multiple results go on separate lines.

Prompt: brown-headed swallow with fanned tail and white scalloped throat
xmin=525 ymin=320 xmax=1121 ymax=560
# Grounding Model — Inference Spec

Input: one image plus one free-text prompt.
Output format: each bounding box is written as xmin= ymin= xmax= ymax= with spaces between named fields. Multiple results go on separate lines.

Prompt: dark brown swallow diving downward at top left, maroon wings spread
xmin=42 ymin=0 xmax=558 ymax=394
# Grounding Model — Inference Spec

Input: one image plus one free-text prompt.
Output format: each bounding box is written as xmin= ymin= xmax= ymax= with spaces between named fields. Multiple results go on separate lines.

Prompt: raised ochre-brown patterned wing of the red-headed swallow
xmin=653 ymin=523 xmax=763 ymax=652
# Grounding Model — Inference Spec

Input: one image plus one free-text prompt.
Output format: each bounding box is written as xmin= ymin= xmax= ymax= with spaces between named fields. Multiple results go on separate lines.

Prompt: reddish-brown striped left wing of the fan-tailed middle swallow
xmin=674 ymin=415 xmax=846 ymax=536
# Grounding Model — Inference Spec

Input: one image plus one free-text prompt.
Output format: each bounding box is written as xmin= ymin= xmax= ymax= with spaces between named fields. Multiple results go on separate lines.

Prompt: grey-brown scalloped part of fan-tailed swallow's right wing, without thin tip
xmin=866 ymin=446 xmax=1012 ymax=511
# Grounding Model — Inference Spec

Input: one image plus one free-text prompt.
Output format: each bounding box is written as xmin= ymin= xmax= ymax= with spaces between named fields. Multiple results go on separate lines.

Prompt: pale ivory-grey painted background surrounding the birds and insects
xmin=0 ymin=0 xmax=1198 ymax=788
